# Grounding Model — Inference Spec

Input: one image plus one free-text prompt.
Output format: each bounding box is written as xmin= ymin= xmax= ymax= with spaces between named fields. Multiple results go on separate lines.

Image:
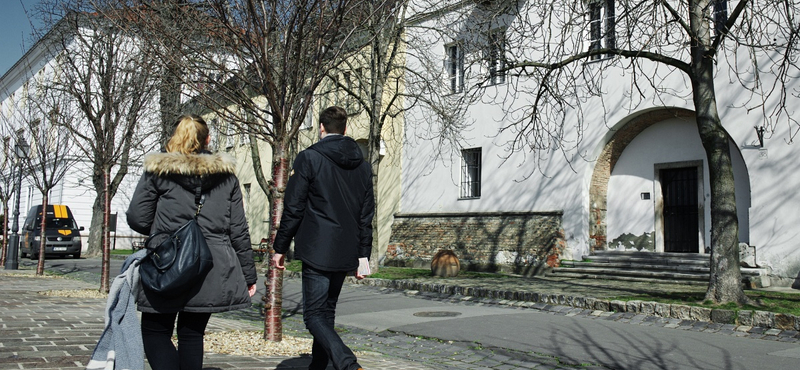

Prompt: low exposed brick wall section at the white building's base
xmin=384 ymin=211 xmax=566 ymax=275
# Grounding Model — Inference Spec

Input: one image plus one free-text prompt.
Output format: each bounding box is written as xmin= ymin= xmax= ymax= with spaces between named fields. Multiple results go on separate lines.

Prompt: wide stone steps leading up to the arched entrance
xmin=546 ymin=251 xmax=770 ymax=288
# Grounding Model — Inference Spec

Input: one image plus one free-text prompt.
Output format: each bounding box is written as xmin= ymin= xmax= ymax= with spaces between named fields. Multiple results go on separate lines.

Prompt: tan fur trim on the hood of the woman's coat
xmin=144 ymin=152 xmax=236 ymax=176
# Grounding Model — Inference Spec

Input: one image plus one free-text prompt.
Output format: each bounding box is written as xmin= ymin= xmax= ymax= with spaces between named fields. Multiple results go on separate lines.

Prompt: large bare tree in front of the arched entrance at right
xmin=412 ymin=0 xmax=800 ymax=303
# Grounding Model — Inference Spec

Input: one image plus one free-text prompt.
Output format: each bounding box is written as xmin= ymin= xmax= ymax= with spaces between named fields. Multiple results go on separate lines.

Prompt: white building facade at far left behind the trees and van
xmin=0 ymin=20 xmax=157 ymax=251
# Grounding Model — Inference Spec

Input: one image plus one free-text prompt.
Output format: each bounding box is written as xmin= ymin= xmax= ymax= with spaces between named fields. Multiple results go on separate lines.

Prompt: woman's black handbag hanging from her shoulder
xmin=139 ymin=191 xmax=214 ymax=295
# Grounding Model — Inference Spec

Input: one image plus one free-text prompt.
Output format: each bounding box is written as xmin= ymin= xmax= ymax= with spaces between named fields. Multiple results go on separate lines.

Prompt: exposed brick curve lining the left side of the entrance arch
xmin=589 ymin=108 xmax=694 ymax=251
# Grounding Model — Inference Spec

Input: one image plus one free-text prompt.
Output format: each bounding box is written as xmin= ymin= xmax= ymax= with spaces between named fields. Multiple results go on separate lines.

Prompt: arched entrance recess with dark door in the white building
xmin=589 ymin=108 xmax=750 ymax=253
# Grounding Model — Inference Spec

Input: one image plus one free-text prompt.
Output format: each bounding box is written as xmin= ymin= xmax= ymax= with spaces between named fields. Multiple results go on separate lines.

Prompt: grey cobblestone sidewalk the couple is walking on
xmin=0 ymin=270 xmax=601 ymax=370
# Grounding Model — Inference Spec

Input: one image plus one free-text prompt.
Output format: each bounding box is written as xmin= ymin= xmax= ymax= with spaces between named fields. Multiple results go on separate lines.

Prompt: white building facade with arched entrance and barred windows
xmin=389 ymin=0 xmax=800 ymax=285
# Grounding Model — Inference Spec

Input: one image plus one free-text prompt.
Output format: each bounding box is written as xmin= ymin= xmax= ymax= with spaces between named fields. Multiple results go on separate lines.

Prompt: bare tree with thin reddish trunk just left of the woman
xmin=36 ymin=0 xmax=158 ymax=291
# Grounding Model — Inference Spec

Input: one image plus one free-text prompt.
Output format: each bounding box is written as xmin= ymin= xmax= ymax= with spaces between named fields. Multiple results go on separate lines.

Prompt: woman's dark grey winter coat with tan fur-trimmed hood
xmin=126 ymin=152 xmax=257 ymax=313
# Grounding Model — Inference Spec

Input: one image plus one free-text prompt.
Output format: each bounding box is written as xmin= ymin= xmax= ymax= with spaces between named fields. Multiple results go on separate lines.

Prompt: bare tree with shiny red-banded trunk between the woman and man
xmin=114 ymin=0 xmax=370 ymax=341
